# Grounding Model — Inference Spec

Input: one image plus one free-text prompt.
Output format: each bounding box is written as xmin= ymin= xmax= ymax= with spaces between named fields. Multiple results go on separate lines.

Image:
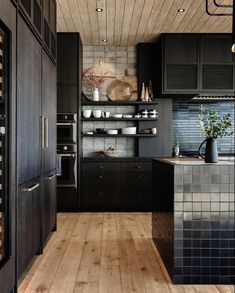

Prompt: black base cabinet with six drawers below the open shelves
xmin=81 ymin=159 xmax=152 ymax=211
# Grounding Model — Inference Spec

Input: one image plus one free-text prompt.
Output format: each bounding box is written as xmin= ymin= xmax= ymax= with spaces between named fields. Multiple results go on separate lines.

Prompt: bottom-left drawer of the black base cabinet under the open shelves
xmin=81 ymin=188 xmax=117 ymax=206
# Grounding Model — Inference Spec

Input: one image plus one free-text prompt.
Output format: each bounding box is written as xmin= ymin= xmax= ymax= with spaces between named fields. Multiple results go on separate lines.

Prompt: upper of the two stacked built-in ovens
xmin=57 ymin=113 xmax=77 ymax=144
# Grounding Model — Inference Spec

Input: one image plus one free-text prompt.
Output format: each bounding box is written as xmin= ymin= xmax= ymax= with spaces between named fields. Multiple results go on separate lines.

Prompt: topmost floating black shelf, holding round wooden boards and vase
xmin=82 ymin=101 xmax=158 ymax=106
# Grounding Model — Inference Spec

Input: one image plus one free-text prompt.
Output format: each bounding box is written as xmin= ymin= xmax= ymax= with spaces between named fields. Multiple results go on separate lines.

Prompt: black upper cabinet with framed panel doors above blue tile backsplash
xmin=153 ymin=34 xmax=234 ymax=97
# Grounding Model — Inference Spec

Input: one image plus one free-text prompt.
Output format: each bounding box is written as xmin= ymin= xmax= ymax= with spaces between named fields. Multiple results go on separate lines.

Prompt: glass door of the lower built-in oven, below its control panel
xmin=57 ymin=154 xmax=77 ymax=188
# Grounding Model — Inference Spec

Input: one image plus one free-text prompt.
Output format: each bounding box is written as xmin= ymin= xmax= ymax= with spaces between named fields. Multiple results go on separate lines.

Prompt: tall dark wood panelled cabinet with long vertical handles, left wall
xmin=17 ymin=1 xmax=56 ymax=278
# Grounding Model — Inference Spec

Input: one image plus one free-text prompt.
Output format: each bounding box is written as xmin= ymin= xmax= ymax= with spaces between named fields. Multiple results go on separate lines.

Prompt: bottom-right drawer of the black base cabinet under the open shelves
xmin=119 ymin=189 xmax=152 ymax=207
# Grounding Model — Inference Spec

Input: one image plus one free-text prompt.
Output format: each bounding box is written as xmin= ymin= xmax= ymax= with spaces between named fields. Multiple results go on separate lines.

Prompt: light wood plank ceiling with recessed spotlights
xmin=57 ymin=0 xmax=232 ymax=45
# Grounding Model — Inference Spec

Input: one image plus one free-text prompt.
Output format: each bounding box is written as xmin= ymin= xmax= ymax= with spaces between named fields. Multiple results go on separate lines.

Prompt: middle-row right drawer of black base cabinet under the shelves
xmin=119 ymin=172 xmax=152 ymax=188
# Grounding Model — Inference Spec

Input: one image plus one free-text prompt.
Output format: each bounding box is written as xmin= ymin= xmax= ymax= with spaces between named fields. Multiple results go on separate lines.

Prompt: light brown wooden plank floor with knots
xmin=19 ymin=213 xmax=234 ymax=293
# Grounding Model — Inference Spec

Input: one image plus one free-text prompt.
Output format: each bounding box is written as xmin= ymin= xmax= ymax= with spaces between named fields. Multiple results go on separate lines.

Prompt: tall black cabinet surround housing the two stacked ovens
xmin=57 ymin=33 xmax=82 ymax=211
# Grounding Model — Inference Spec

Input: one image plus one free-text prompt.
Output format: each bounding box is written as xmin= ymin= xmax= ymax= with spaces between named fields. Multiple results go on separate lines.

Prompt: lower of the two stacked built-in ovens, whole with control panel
xmin=57 ymin=145 xmax=77 ymax=188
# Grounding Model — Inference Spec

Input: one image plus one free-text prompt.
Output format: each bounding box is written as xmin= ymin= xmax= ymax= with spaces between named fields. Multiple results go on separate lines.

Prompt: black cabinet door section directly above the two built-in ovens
xmin=57 ymin=33 xmax=82 ymax=113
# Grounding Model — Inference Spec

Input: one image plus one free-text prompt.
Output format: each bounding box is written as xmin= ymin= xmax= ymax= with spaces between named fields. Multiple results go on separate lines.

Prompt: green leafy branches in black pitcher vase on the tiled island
xmin=198 ymin=108 xmax=233 ymax=163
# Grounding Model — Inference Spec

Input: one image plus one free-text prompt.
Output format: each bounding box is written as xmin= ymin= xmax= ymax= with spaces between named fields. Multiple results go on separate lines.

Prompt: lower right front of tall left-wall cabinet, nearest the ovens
xmin=42 ymin=170 xmax=56 ymax=243
